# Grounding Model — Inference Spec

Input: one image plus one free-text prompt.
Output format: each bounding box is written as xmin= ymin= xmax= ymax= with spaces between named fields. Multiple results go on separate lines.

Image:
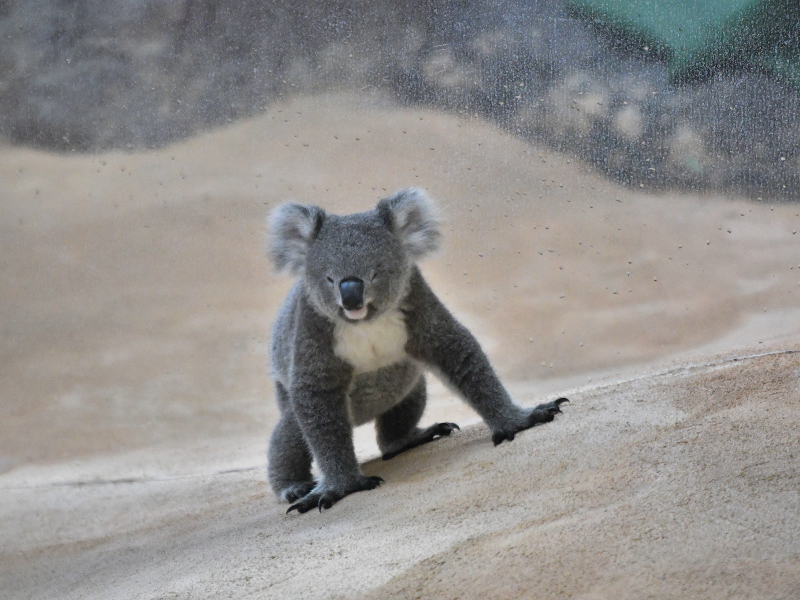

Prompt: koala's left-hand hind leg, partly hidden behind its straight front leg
xmin=268 ymin=384 xmax=315 ymax=502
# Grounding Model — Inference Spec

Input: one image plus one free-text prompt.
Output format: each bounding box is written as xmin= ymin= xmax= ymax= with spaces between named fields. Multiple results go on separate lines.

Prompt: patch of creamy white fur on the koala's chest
xmin=333 ymin=310 xmax=408 ymax=375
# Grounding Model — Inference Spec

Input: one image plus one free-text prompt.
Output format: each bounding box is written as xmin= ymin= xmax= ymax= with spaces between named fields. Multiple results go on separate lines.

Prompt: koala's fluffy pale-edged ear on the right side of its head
xmin=377 ymin=188 xmax=442 ymax=260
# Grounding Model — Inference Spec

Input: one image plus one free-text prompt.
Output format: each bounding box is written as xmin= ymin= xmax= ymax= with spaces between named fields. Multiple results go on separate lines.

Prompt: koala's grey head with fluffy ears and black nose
xmin=270 ymin=189 xmax=441 ymax=322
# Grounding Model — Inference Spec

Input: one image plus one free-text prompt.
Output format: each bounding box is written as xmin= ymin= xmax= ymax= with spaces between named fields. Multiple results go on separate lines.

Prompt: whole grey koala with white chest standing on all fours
xmin=268 ymin=189 xmax=568 ymax=513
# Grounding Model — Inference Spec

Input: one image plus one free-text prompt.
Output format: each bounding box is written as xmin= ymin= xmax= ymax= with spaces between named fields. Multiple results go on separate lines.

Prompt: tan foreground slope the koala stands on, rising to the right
xmin=2 ymin=344 xmax=800 ymax=599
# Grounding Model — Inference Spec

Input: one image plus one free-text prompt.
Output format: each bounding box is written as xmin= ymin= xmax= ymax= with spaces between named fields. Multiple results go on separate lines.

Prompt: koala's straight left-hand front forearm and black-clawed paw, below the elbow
xmin=286 ymin=382 xmax=383 ymax=513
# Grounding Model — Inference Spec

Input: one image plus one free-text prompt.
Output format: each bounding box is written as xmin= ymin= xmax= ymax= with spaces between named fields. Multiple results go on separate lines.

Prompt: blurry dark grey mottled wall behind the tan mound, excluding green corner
xmin=0 ymin=0 xmax=800 ymax=199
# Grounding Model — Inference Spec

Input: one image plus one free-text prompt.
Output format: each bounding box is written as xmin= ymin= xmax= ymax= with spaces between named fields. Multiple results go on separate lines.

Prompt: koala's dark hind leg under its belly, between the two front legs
xmin=375 ymin=377 xmax=459 ymax=460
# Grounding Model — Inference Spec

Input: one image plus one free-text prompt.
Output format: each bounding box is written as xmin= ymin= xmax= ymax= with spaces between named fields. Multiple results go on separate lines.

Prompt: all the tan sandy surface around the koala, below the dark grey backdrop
xmin=0 ymin=96 xmax=800 ymax=598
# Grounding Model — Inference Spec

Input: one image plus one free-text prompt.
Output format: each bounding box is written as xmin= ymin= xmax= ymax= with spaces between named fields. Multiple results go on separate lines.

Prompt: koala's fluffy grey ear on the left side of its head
xmin=269 ymin=202 xmax=325 ymax=275
